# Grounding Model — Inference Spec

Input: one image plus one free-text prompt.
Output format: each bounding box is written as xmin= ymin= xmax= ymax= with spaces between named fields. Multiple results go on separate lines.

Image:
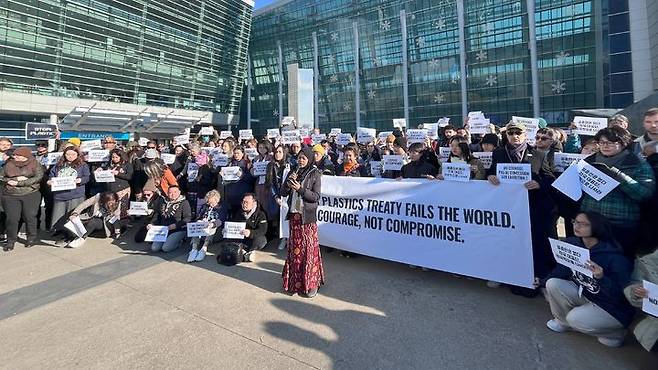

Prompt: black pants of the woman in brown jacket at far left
xmin=2 ymin=191 xmax=41 ymax=243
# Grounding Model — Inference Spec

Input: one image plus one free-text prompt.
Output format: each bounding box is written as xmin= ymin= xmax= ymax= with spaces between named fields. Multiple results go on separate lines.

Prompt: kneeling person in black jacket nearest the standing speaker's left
xmin=217 ymin=193 xmax=267 ymax=262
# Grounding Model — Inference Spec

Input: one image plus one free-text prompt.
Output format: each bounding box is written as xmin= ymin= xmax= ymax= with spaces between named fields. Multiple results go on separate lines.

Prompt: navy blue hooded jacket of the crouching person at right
xmin=548 ymin=237 xmax=635 ymax=327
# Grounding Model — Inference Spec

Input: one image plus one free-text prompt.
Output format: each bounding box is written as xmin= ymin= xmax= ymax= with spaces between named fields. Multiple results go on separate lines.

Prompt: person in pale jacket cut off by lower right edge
xmin=624 ymin=247 xmax=658 ymax=352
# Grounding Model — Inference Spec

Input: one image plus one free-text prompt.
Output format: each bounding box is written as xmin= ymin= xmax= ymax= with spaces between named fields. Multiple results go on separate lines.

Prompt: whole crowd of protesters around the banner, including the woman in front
xmin=0 ymin=108 xmax=658 ymax=351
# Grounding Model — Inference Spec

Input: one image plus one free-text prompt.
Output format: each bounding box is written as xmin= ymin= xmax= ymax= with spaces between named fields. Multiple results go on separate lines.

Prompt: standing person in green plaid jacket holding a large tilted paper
xmin=580 ymin=126 xmax=655 ymax=259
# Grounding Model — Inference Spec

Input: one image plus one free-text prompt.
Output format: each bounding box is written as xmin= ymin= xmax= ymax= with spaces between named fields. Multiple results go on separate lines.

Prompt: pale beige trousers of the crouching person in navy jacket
xmin=546 ymin=278 xmax=626 ymax=339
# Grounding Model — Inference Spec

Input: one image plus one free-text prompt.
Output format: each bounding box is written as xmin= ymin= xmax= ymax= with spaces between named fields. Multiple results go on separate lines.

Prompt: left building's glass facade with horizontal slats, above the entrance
xmin=0 ymin=0 xmax=253 ymax=125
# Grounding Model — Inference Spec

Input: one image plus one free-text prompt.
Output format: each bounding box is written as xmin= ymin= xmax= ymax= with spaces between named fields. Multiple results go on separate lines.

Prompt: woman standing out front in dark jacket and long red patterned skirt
xmin=281 ymin=148 xmax=322 ymax=298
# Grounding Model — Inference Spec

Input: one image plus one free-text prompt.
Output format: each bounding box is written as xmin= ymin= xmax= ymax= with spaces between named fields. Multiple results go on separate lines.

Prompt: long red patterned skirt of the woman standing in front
xmin=282 ymin=213 xmax=324 ymax=293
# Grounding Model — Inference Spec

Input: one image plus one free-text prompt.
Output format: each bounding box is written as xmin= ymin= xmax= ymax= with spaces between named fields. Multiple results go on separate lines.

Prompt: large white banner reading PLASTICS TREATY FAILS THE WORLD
xmin=317 ymin=176 xmax=534 ymax=288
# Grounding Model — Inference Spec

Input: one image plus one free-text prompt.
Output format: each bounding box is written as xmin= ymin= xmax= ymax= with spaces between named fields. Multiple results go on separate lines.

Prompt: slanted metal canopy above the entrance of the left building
xmin=60 ymin=104 xmax=208 ymax=135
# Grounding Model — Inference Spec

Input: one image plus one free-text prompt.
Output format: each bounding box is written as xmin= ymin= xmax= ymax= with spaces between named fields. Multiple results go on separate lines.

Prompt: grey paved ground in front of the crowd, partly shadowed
xmin=0 ymin=230 xmax=658 ymax=369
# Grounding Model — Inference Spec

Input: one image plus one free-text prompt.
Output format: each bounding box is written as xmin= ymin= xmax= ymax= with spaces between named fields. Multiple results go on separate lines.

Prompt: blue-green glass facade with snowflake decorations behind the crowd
xmin=242 ymin=0 xmax=633 ymax=132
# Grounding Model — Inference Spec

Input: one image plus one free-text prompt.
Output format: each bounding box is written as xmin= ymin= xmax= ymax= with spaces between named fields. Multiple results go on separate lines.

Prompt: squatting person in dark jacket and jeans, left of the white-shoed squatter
xmin=146 ymin=185 xmax=192 ymax=253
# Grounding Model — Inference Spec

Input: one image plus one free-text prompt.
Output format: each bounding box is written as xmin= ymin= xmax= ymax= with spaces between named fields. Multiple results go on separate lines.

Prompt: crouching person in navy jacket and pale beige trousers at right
xmin=546 ymin=212 xmax=635 ymax=347
